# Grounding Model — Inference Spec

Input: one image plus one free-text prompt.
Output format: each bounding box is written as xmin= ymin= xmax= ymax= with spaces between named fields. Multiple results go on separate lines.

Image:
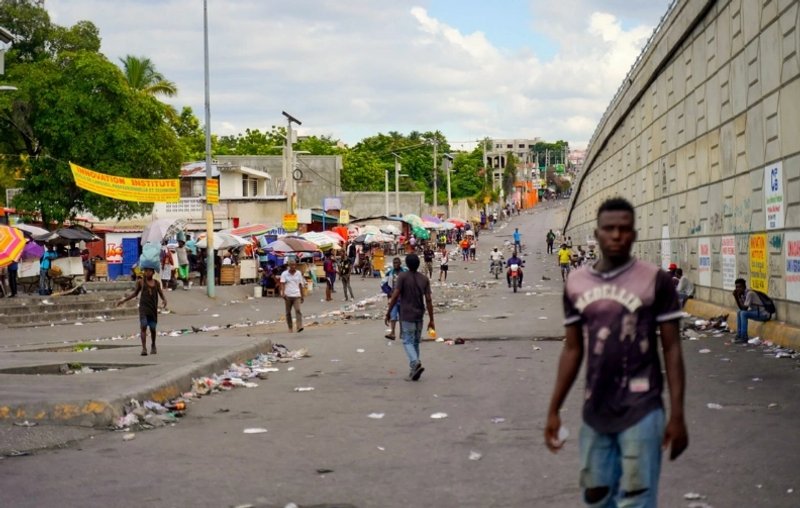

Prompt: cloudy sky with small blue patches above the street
xmin=46 ymin=0 xmax=671 ymax=148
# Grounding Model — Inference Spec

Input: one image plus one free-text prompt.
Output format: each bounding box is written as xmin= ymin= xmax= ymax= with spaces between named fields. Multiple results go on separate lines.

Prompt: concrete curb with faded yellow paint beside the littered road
xmin=0 ymin=339 xmax=272 ymax=427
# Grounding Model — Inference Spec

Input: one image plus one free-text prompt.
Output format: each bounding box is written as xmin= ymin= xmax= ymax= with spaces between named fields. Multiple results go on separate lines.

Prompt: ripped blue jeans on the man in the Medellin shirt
xmin=580 ymin=408 xmax=664 ymax=508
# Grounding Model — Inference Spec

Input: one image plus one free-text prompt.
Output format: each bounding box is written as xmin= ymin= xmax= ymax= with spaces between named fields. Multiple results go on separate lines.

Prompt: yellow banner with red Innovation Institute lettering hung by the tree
xmin=69 ymin=162 xmax=181 ymax=203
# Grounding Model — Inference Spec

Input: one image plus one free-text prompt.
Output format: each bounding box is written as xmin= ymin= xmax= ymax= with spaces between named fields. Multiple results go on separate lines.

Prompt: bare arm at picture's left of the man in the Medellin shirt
xmin=544 ymin=323 xmax=583 ymax=453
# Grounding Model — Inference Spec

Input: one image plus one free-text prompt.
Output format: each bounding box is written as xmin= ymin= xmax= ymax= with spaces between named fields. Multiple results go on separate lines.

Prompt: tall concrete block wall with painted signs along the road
xmin=565 ymin=0 xmax=800 ymax=324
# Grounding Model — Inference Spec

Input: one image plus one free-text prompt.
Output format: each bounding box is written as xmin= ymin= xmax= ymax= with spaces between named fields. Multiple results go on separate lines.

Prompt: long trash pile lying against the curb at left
xmin=113 ymin=344 xmax=309 ymax=432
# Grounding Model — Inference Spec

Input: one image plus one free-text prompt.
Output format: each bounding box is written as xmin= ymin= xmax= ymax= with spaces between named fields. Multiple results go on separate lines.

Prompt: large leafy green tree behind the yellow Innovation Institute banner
xmin=0 ymin=51 xmax=181 ymax=223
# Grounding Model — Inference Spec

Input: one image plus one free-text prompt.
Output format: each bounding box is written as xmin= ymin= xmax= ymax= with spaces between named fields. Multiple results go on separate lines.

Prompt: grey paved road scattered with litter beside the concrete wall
xmin=0 ymin=203 xmax=800 ymax=508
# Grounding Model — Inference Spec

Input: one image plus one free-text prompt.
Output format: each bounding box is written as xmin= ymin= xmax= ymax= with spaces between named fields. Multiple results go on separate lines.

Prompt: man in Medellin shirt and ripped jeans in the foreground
xmin=544 ymin=198 xmax=689 ymax=508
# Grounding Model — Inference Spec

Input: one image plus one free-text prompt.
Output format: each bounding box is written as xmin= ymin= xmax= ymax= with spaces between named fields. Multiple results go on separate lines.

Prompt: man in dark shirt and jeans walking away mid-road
xmin=385 ymin=254 xmax=436 ymax=381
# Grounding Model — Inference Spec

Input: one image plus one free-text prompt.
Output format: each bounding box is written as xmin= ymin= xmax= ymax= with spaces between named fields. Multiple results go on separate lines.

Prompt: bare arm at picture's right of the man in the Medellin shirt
xmin=660 ymin=320 xmax=689 ymax=460
